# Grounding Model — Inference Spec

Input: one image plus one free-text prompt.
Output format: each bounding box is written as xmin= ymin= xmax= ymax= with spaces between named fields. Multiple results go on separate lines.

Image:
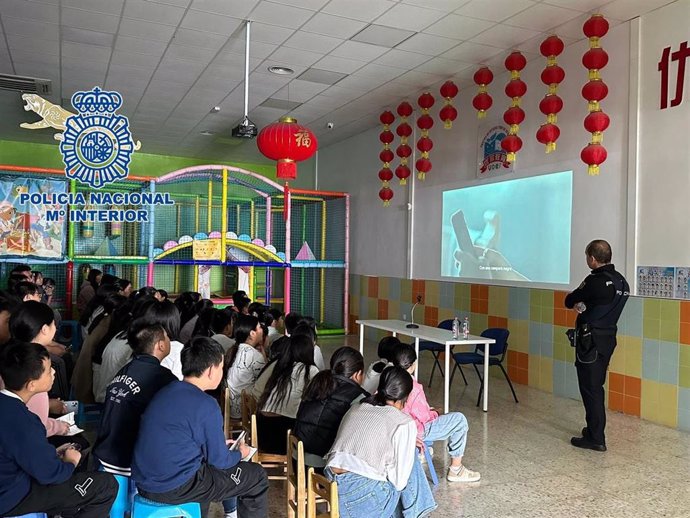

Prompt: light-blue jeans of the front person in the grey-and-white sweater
xmin=325 ymin=456 xmax=436 ymax=518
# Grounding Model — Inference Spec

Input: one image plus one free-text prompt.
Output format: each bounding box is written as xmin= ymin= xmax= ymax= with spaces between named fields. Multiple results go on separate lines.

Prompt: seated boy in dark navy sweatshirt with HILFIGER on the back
xmin=93 ymin=320 xmax=177 ymax=476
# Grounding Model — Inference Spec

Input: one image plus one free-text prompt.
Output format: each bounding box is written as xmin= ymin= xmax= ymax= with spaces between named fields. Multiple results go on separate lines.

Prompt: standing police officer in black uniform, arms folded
xmin=565 ymin=239 xmax=630 ymax=451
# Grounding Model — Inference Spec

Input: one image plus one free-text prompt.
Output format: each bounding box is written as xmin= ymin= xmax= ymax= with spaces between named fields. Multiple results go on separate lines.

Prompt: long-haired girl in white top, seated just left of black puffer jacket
xmin=256 ymin=335 xmax=319 ymax=454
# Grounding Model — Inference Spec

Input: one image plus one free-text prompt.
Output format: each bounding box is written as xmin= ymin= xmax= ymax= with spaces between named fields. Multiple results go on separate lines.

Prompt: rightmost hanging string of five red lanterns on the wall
xmin=580 ymin=14 xmax=610 ymax=175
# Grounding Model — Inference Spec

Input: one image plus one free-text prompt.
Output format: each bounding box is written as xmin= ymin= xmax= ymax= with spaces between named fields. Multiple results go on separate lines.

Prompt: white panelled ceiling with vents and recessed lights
xmin=0 ymin=0 xmax=672 ymax=165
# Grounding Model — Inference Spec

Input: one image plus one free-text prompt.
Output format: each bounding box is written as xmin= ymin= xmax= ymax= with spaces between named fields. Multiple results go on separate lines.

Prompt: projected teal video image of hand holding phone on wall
xmin=441 ymin=171 xmax=573 ymax=284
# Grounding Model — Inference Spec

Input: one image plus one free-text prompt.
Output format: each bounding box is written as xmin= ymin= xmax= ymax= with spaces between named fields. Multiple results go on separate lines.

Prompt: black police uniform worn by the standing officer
xmin=565 ymin=264 xmax=630 ymax=445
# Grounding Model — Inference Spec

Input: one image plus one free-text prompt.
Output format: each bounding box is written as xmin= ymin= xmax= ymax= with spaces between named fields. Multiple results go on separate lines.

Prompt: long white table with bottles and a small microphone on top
xmin=357 ymin=320 xmax=496 ymax=414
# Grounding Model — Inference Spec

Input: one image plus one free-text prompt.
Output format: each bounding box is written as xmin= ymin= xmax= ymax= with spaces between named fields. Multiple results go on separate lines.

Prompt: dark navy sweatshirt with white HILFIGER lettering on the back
xmin=94 ymin=354 xmax=177 ymax=474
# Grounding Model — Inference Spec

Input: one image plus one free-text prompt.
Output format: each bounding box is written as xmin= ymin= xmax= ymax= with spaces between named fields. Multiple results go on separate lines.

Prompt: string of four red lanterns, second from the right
xmin=537 ymin=34 xmax=565 ymax=153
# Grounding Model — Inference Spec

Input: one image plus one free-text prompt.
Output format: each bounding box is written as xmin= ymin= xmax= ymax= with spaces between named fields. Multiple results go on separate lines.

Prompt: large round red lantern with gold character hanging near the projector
xmin=256 ymin=117 xmax=318 ymax=180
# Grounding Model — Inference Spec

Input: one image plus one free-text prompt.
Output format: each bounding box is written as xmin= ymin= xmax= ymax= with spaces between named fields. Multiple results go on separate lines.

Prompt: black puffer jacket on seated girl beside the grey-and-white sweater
xmin=294 ymin=375 xmax=369 ymax=457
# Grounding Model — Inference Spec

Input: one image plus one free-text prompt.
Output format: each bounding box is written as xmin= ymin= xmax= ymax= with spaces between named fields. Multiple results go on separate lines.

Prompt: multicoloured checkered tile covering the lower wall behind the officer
xmin=350 ymin=275 xmax=690 ymax=430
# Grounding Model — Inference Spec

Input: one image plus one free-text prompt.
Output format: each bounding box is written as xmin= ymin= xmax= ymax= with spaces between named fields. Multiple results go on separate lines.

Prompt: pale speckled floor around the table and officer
xmin=211 ymin=337 xmax=690 ymax=518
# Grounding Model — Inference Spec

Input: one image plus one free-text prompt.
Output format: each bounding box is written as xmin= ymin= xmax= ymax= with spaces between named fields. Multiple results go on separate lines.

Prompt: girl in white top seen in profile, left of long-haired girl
xmin=227 ymin=314 xmax=266 ymax=419
